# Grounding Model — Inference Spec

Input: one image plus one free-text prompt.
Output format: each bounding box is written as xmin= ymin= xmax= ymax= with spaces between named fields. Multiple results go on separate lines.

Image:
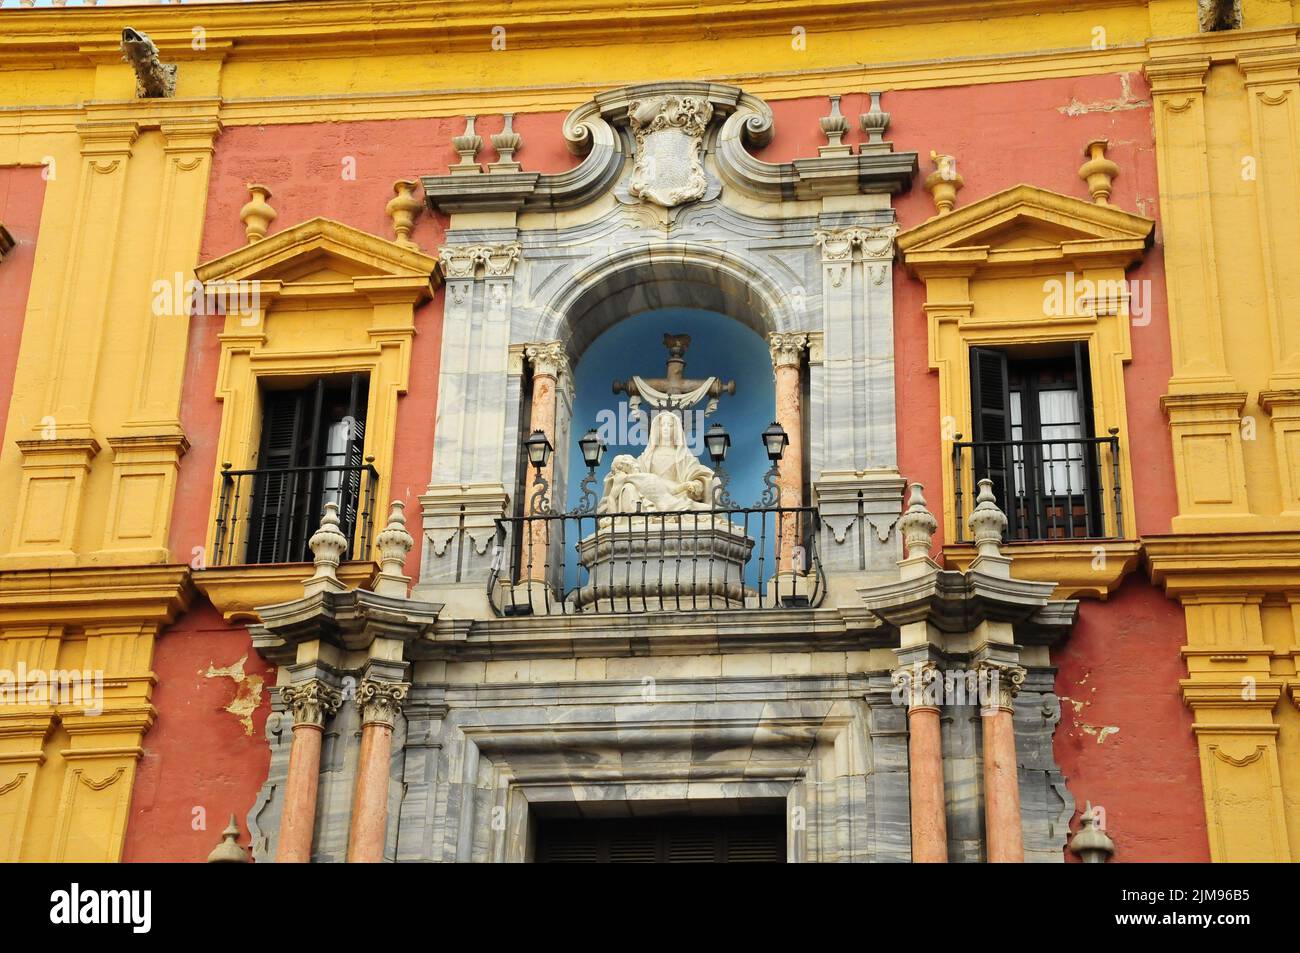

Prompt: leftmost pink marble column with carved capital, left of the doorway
xmin=276 ymin=679 xmax=342 ymax=863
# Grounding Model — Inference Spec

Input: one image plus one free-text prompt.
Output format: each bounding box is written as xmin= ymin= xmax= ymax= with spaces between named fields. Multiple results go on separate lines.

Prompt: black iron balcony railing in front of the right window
xmin=953 ymin=429 xmax=1125 ymax=542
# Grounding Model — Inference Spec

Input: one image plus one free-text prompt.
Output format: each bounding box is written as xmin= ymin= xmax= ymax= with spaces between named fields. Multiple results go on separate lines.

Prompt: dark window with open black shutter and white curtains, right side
xmin=970 ymin=342 xmax=1104 ymax=540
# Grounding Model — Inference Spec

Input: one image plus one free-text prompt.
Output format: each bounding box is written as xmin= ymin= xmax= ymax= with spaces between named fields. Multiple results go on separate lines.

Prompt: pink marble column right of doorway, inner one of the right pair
xmin=894 ymin=662 xmax=948 ymax=863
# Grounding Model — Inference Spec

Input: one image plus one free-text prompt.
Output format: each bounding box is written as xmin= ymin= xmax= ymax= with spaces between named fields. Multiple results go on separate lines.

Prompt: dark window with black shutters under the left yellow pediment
xmin=246 ymin=374 xmax=368 ymax=563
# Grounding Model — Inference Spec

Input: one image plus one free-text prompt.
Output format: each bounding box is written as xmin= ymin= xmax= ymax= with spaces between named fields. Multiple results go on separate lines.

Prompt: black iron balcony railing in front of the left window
xmin=212 ymin=463 xmax=380 ymax=566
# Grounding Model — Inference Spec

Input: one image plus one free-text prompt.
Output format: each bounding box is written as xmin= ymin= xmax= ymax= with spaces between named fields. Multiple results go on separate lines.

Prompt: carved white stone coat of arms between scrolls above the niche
xmin=628 ymin=96 xmax=714 ymax=208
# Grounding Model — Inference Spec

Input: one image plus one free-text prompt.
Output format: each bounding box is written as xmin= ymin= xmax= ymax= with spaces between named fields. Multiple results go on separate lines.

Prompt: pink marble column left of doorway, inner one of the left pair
xmin=347 ymin=679 xmax=411 ymax=863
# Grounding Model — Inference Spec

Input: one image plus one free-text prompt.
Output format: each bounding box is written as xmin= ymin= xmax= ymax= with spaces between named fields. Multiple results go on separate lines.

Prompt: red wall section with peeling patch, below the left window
xmin=122 ymin=602 xmax=276 ymax=861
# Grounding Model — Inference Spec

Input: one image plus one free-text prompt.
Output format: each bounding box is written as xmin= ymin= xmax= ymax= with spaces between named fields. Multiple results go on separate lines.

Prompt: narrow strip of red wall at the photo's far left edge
xmin=0 ymin=166 xmax=46 ymax=439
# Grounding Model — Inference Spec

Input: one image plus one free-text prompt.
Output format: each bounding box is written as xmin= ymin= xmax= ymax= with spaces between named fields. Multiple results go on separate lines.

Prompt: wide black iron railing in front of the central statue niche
xmin=488 ymin=507 xmax=826 ymax=616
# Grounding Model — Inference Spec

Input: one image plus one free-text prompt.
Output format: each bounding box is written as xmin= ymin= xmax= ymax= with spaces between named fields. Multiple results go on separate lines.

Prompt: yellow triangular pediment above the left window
xmin=196 ymin=218 xmax=438 ymax=285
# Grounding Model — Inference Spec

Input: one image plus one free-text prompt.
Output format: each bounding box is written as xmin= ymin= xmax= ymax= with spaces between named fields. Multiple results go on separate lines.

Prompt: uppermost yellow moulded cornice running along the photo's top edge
xmin=0 ymin=0 xmax=1144 ymax=65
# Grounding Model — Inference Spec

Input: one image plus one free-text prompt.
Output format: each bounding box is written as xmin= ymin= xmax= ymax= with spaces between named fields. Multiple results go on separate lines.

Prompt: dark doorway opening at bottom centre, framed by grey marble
xmin=536 ymin=814 xmax=785 ymax=863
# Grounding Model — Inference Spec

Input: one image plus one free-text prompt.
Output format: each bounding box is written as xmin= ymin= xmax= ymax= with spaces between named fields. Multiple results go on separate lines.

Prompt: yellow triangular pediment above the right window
xmin=898 ymin=185 xmax=1156 ymax=264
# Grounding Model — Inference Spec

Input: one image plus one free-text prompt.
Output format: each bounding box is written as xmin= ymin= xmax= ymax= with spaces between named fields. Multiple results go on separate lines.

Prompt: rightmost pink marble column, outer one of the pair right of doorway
xmin=979 ymin=662 xmax=1024 ymax=863
